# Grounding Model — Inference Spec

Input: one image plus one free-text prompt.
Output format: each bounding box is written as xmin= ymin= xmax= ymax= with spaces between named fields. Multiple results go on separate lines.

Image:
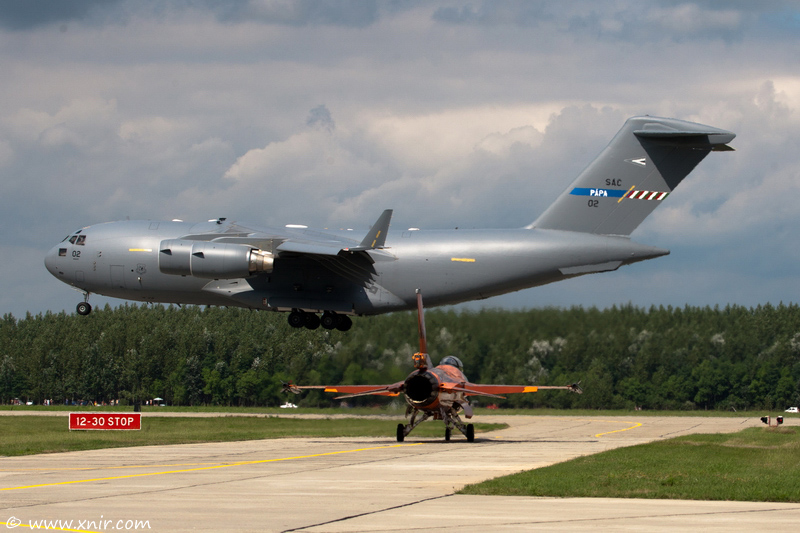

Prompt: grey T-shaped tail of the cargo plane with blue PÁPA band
xmin=528 ymin=116 xmax=736 ymax=236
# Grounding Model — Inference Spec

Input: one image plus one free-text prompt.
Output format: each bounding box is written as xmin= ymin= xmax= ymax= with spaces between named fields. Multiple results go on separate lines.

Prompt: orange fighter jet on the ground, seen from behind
xmin=284 ymin=289 xmax=583 ymax=442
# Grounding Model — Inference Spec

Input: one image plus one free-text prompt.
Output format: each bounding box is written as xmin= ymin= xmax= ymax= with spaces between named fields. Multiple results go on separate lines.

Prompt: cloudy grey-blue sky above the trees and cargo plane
xmin=0 ymin=0 xmax=800 ymax=317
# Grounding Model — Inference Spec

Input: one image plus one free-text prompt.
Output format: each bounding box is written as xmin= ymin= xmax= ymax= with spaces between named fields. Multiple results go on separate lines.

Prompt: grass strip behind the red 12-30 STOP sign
xmin=0 ymin=415 xmax=508 ymax=456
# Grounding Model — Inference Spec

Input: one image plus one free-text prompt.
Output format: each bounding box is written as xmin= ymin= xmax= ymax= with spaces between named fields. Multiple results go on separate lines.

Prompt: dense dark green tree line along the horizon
xmin=0 ymin=304 xmax=800 ymax=410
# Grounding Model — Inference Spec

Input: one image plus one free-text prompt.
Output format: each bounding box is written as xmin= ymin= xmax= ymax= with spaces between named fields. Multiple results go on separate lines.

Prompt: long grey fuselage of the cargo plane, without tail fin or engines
xmin=45 ymin=217 xmax=668 ymax=315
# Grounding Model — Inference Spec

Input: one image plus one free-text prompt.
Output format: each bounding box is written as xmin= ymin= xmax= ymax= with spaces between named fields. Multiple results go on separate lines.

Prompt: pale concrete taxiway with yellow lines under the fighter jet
xmin=0 ymin=414 xmax=800 ymax=533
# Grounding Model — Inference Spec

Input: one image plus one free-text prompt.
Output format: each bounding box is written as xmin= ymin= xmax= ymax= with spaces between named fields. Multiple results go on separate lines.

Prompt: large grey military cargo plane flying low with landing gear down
xmin=45 ymin=116 xmax=735 ymax=330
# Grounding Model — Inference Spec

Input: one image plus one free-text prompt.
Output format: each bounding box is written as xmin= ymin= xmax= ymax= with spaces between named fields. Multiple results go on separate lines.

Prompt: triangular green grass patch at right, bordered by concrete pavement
xmin=459 ymin=427 xmax=800 ymax=502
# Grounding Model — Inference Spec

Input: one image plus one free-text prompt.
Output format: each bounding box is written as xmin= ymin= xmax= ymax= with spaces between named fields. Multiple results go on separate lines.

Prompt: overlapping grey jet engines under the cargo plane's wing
xmin=158 ymin=239 xmax=275 ymax=279
